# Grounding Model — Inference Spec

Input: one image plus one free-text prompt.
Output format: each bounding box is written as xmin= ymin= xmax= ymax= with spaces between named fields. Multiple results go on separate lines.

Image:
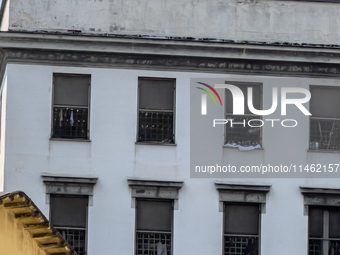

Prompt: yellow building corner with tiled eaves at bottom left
xmin=0 ymin=191 xmax=76 ymax=255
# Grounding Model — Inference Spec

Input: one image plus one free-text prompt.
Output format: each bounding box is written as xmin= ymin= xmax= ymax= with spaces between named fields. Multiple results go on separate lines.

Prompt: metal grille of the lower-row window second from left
xmin=136 ymin=230 xmax=172 ymax=255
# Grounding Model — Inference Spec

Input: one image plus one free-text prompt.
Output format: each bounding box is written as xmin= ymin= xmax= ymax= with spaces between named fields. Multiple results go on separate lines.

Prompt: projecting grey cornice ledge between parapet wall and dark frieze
xmin=0 ymin=32 xmax=340 ymax=64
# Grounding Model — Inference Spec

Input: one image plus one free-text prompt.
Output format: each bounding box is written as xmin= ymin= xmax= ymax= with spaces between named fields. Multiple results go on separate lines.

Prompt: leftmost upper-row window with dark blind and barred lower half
xmin=52 ymin=74 xmax=90 ymax=139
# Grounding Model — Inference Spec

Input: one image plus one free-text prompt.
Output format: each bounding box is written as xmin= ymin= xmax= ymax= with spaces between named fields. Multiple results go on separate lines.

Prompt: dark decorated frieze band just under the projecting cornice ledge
xmin=4 ymin=49 xmax=340 ymax=77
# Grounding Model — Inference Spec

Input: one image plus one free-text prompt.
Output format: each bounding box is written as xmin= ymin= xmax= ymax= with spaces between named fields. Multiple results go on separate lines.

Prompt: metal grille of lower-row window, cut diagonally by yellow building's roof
xmin=57 ymin=229 xmax=86 ymax=255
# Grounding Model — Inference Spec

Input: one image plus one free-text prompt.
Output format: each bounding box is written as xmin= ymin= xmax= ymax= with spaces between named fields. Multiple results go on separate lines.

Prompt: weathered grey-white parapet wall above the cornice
xmin=5 ymin=0 xmax=340 ymax=44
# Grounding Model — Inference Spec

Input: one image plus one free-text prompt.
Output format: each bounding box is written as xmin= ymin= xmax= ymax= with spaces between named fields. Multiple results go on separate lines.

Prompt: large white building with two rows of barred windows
xmin=0 ymin=0 xmax=340 ymax=255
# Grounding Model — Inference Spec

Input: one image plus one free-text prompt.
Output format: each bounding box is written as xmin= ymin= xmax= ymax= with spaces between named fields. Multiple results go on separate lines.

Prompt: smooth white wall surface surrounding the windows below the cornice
xmin=5 ymin=64 xmax=339 ymax=255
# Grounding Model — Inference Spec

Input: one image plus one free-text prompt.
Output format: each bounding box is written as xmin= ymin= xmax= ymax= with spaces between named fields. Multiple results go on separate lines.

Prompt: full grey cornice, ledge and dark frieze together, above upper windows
xmin=0 ymin=32 xmax=340 ymax=82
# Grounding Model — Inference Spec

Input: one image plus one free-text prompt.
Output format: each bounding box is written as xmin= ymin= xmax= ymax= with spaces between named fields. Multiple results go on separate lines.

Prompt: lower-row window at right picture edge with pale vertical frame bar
xmin=308 ymin=206 xmax=340 ymax=255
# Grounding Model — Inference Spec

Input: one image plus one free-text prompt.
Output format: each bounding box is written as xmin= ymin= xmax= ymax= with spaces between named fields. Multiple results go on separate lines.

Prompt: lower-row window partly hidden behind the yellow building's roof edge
xmin=50 ymin=195 xmax=88 ymax=255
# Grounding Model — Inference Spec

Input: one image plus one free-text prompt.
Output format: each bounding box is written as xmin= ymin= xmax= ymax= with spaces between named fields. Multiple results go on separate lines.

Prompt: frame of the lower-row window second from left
xmin=134 ymin=197 xmax=175 ymax=255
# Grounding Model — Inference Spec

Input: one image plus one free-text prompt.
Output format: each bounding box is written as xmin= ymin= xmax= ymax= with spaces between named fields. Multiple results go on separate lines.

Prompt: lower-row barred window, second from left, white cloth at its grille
xmin=135 ymin=200 xmax=173 ymax=255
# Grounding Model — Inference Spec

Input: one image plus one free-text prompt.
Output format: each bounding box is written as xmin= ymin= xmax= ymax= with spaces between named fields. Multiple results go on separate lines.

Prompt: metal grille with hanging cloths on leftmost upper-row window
xmin=52 ymin=106 xmax=88 ymax=139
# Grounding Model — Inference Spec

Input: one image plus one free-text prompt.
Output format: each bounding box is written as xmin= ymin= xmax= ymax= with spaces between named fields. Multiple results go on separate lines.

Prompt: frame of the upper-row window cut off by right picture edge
xmin=307 ymin=85 xmax=340 ymax=153
